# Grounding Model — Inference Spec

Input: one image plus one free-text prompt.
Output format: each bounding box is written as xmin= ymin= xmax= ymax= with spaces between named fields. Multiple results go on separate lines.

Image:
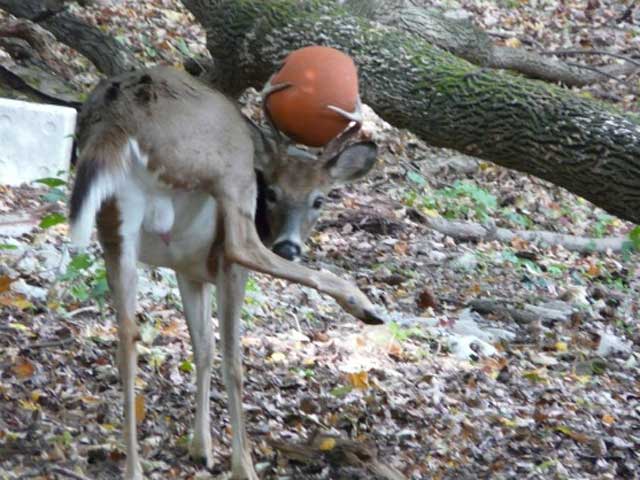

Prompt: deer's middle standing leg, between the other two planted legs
xmin=176 ymin=274 xmax=215 ymax=468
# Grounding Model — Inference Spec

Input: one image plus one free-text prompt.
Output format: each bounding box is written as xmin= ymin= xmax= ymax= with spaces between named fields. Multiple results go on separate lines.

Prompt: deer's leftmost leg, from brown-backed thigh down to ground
xmin=98 ymin=199 xmax=143 ymax=480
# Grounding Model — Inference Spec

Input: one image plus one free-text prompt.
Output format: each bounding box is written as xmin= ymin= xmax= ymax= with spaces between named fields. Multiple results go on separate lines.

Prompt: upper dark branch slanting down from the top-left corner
xmin=0 ymin=0 xmax=141 ymax=75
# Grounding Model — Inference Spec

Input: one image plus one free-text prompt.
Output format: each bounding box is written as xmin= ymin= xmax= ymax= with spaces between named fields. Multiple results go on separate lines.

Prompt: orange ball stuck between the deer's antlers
xmin=266 ymin=46 xmax=358 ymax=147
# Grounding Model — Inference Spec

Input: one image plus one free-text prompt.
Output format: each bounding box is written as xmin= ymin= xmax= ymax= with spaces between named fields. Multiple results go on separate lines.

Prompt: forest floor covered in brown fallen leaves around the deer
xmin=0 ymin=0 xmax=640 ymax=480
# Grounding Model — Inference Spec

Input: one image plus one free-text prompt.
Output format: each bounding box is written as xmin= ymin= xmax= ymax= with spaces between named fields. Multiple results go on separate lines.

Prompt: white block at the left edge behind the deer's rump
xmin=0 ymin=98 xmax=76 ymax=185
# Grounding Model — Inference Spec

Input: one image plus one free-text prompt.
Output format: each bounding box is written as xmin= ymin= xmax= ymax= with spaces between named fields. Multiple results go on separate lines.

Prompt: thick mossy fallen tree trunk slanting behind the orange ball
xmin=183 ymin=0 xmax=640 ymax=223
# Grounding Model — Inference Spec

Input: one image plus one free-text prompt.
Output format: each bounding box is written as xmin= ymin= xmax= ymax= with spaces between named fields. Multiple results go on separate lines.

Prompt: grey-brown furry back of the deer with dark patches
xmin=78 ymin=67 xmax=253 ymax=193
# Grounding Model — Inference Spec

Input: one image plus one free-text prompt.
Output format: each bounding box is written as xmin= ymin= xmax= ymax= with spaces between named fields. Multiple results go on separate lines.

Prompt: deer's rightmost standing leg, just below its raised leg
xmin=216 ymin=255 xmax=258 ymax=480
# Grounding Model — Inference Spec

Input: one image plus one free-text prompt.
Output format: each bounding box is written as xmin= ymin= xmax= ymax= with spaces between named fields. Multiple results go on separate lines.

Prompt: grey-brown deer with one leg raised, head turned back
xmin=70 ymin=67 xmax=382 ymax=480
